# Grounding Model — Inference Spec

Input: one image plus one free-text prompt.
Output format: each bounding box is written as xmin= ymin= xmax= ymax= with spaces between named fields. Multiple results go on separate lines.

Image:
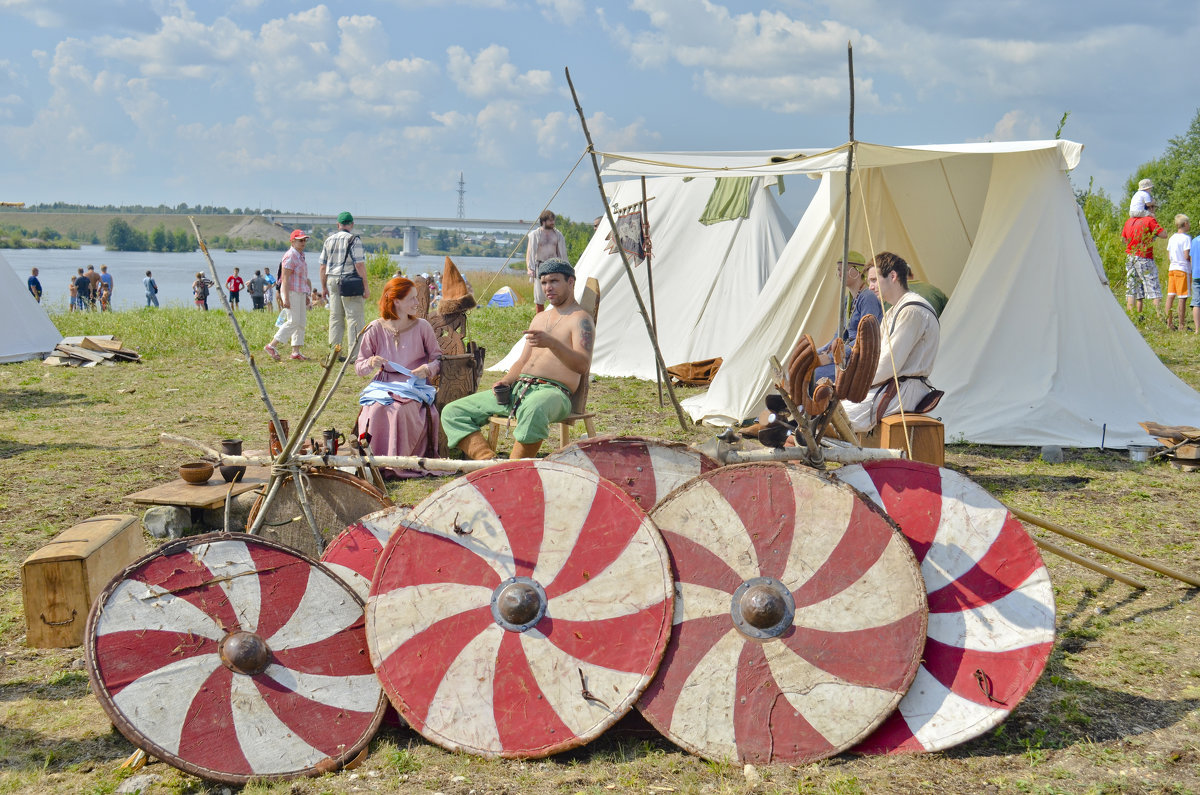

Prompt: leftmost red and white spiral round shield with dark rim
xmin=84 ymin=533 xmax=388 ymax=783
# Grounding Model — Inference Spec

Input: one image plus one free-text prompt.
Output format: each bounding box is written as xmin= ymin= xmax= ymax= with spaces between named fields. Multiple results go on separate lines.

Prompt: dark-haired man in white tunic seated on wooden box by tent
xmin=842 ymin=251 xmax=941 ymax=432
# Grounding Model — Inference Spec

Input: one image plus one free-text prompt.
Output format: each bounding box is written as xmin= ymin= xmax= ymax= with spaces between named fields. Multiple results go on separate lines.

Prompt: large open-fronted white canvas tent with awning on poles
xmin=605 ymin=141 xmax=1200 ymax=447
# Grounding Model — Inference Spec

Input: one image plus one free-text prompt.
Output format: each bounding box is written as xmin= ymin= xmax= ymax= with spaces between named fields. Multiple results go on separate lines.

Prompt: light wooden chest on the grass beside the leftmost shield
xmin=20 ymin=514 xmax=146 ymax=648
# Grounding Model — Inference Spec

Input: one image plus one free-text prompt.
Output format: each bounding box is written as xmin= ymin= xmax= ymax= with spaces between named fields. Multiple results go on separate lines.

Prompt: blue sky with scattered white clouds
xmin=0 ymin=0 xmax=1200 ymax=220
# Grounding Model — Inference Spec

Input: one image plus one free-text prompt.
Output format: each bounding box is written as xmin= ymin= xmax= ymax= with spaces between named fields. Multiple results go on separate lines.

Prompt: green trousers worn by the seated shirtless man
xmin=442 ymin=381 xmax=571 ymax=447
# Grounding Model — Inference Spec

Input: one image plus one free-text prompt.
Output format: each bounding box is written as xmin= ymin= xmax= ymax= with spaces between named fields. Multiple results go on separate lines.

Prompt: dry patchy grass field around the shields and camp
xmin=0 ymin=274 xmax=1200 ymax=795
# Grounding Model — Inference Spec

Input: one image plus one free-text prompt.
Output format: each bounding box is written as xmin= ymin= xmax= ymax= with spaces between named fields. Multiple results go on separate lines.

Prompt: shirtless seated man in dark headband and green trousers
xmin=442 ymin=258 xmax=595 ymax=460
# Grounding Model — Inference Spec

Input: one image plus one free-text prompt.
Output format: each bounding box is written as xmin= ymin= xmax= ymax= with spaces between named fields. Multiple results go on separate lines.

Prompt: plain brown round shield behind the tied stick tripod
xmin=246 ymin=470 xmax=392 ymax=557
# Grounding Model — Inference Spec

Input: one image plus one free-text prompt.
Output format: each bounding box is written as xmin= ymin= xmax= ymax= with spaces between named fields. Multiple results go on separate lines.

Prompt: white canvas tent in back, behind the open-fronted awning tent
xmin=491 ymin=178 xmax=792 ymax=379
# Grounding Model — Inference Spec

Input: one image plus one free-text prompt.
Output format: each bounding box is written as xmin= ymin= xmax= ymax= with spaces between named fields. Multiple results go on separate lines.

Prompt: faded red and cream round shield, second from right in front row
xmin=637 ymin=464 xmax=926 ymax=764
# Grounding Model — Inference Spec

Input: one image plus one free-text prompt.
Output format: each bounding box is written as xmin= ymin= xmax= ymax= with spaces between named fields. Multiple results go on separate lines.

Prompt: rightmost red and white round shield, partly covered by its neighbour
xmin=836 ymin=461 xmax=1055 ymax=753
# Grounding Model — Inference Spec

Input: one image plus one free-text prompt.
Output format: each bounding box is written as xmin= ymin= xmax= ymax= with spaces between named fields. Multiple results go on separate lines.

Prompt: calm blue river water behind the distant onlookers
xmin=0 ymin=246 xmax=524 ymax=310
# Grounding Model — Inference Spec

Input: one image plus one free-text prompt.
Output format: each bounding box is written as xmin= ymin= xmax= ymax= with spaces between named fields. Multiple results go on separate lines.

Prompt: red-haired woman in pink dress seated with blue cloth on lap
xmin=354 ymin=276 xmax=442 ymax=478
